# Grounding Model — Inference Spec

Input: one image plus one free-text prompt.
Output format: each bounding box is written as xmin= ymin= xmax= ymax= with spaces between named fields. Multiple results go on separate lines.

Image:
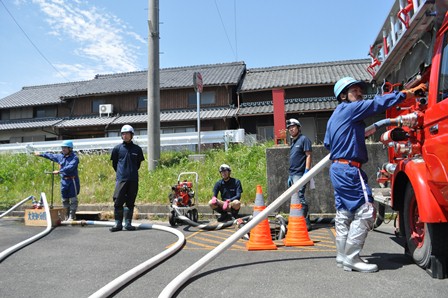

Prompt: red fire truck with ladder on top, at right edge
xmin=367 ymin=0 xmax=448 ymax=279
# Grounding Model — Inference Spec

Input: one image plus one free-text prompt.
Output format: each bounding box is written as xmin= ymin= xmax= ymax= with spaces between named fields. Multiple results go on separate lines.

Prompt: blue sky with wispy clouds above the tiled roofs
xmin=0 ymin=0 xmax=394 ymax=98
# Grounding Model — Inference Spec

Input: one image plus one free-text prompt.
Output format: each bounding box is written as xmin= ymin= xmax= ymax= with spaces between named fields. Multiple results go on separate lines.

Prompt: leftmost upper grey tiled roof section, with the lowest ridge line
xmin=0 ymin=82 xmax=85 ymax=109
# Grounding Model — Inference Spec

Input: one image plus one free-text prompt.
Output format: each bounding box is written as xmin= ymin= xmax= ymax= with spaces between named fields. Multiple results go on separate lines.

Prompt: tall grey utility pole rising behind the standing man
xmin=147 ymin=0 xmax=160 ymax=171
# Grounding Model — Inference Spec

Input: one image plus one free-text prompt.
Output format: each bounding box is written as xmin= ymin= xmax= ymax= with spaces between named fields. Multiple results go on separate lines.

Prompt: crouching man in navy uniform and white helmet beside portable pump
xmin=208 ymin=164 xmax=243 ymax=222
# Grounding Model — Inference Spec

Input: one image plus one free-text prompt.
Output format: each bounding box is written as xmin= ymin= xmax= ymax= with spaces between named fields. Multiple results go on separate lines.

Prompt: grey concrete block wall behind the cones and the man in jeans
xmin=266 ymin=143 xmax=387 ymax=214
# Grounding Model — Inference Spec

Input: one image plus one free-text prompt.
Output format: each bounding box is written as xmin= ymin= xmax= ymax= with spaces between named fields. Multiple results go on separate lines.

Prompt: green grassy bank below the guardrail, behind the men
xmin=0 ymin=142 xmax=274 ymax=210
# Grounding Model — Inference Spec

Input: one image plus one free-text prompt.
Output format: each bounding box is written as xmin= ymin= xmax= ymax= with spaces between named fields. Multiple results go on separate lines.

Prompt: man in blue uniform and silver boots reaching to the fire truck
xmin=324 ymin=77 xmax=427 ymax=272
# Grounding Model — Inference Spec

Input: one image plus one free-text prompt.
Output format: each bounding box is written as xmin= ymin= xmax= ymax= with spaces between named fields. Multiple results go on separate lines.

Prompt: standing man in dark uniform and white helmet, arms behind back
xmin=110 ymin=125 xmax=145 ymax=232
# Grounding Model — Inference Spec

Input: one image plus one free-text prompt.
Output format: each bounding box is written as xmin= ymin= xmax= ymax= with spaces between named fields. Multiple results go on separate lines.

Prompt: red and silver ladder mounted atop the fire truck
xmin=367 ymin=0 xmax=435 ymax=82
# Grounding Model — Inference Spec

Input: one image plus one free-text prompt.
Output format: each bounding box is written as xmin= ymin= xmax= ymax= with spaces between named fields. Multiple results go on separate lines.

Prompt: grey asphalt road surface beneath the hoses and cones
xmin=0 ymin=218 xmax=448 ymax=297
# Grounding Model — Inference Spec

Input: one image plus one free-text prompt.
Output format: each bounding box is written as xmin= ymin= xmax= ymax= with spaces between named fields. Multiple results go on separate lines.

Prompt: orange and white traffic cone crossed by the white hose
xmin=246 ymin=185 xmax=277 ymax=250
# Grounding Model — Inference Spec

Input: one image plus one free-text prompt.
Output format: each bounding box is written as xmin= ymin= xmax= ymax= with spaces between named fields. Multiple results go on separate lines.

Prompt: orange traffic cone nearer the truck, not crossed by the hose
xmin=283 ymin=193 xmax=314 ymax=246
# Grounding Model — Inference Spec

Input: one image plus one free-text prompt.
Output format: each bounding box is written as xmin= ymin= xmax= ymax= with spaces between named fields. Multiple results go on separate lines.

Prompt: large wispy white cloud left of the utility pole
xmin=33 ymin=0 xmax=146 ymax=77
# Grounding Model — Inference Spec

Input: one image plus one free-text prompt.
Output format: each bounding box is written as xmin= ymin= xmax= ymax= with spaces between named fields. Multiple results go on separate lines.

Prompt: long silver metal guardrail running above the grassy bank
xmin=0 ymin=129 xmax=245 ymax=153
